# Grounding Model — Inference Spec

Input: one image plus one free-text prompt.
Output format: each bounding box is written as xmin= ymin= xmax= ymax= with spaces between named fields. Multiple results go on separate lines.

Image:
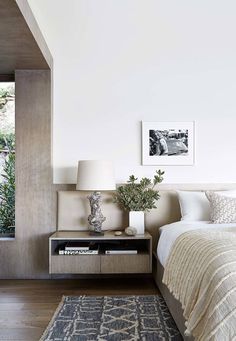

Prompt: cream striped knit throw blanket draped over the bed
xmin=162 ymin=227 xmax=236 ymax=341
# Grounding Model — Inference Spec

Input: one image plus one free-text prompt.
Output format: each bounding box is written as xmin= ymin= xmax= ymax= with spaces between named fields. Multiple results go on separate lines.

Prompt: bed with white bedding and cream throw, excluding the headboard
xmin=154 ymin=192 xmax=236 ymax=341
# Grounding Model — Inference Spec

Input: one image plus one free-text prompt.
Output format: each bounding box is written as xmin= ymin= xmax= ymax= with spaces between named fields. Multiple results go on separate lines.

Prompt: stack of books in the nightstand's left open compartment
xmin=58 ymin=242 xmax=99 ymax=255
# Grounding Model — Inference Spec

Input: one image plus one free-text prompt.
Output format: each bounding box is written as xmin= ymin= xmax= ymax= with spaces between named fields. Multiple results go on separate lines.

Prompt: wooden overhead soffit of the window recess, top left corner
xmin=0 ymin=0 xmax=53 ymax=74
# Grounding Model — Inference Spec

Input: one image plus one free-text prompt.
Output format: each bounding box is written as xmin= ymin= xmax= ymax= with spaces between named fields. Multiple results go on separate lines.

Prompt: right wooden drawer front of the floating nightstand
xmin=101 ymin=254 xmax=151 ymax=274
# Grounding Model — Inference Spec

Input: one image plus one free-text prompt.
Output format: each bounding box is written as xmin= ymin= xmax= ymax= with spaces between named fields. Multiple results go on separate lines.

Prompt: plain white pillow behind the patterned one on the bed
xmin=177 ymin=190 xmax=236 ymax=221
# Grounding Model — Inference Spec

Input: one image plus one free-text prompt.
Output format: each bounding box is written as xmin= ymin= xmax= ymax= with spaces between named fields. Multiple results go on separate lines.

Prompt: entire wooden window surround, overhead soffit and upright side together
xmin=0 ymin=0 xmax=57 ymax=278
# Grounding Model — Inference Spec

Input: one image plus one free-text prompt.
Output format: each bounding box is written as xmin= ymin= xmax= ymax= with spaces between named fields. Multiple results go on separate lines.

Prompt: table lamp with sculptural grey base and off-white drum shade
xmin=76 ymin=160 xmax=116 ymax=236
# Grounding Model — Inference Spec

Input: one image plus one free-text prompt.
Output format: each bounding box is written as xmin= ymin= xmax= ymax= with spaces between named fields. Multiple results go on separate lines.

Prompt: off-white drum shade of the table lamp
xmin=76 ymin=160 xmax=116 ymax=191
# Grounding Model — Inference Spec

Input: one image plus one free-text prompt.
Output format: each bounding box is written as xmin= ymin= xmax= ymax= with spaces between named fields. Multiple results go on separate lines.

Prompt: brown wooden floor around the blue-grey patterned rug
xmin=0 ymin=277 xmax=159 ymax=341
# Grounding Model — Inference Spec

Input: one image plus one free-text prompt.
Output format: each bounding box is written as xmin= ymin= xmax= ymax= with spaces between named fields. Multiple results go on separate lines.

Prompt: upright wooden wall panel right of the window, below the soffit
xmin=0 ymin=70 xmax=56 ymax=278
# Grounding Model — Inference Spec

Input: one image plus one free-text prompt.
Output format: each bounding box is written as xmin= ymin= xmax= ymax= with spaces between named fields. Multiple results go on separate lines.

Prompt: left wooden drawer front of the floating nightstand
xmin=50 ymin=255 xmax=100 ymax=274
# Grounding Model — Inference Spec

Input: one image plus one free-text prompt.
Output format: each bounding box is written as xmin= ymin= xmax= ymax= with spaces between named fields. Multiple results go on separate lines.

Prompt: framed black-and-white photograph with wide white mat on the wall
xmin=142 ymin=122 xmax=194 ymax=166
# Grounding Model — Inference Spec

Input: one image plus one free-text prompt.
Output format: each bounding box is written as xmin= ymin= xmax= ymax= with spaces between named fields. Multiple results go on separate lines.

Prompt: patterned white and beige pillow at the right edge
xmin=206 ymin=191 xmax=236 ymax=224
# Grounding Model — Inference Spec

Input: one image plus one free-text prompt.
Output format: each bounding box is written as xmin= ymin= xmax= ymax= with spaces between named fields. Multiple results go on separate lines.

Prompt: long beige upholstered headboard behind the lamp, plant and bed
xmin=57 ymin=184 xmax=236 ymax=245
